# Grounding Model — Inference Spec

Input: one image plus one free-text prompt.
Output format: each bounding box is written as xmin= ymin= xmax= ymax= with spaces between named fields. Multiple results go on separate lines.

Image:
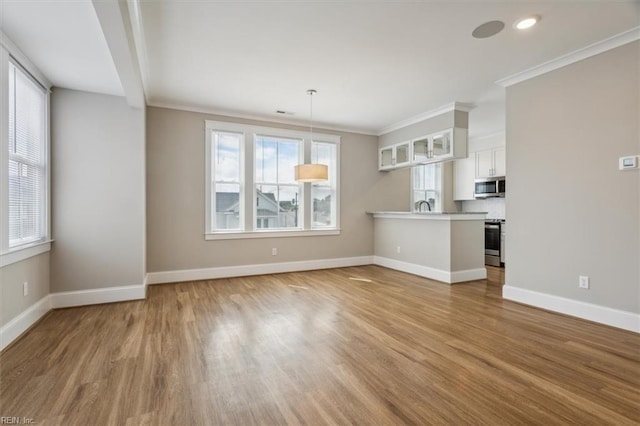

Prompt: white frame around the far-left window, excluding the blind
xmin=0 ymin=37 xmax=53 ymax=267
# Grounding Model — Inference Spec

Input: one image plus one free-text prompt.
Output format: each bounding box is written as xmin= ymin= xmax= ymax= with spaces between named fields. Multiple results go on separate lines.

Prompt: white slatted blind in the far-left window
xmin=8 ymin=62 xmax=47 ymax=248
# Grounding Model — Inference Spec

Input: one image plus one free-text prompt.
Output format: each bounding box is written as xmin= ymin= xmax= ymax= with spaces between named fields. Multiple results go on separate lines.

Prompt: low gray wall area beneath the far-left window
xmin=0 ymin=253 xmax=49 ymax=327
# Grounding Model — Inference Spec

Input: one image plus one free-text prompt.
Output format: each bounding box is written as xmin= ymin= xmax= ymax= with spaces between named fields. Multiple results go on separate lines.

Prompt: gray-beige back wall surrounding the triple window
xmin=147 ymin=107 xmax=402 ymax=272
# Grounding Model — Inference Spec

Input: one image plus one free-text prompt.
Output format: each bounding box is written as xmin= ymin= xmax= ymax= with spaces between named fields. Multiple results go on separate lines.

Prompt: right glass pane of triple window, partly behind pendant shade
xmin=311 ymin=142 xmax=337 ymax=228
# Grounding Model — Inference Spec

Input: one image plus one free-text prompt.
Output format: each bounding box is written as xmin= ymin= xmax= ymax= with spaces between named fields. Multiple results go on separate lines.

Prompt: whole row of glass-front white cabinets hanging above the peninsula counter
xmin=378 ymin=128 xmax=468 ymax=170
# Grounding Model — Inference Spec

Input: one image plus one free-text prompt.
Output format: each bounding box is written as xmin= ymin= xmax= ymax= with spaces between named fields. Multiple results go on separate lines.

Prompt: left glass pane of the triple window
xmin=211 ymin=131 xmax=243 ymax=230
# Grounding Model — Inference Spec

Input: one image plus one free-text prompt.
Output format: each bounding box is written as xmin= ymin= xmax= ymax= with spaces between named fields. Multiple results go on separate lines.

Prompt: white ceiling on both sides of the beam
xmin=0 ymin=0 xmax=640 ymax=137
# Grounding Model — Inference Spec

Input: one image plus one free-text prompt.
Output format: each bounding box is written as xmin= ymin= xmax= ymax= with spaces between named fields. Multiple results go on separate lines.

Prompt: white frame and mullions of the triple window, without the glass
xmin=204 ymin=120 xmax=341 ymax=240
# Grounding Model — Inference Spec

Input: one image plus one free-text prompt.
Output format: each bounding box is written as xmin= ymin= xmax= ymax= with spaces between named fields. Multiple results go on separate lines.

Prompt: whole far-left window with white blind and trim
xmin=0 ymin=46 xmax=49 ymax=264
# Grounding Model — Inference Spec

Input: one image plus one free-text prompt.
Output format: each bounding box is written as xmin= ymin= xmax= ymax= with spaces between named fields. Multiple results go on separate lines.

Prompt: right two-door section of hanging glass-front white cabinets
xmin=411 ymin=128 xmax=468 ymax=165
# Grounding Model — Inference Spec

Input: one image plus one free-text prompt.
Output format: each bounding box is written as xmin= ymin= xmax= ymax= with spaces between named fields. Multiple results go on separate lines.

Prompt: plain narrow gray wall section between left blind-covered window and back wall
xmin=51 ymin=89 xmax=146 ymax=293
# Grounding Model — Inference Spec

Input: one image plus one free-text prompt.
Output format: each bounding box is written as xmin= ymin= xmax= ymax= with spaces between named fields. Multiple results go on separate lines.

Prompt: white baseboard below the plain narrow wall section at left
xmin=49 ymin=284 xmax=146 ymax=309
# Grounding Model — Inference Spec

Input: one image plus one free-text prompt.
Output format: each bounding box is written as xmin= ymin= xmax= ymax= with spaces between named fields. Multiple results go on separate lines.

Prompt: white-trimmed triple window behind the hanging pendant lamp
xmin=205 ymin=120 xmax=340 ymax=239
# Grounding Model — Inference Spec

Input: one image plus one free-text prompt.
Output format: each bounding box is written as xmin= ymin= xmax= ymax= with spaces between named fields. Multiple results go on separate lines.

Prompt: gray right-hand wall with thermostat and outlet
xmin=506 ymin=42 xmax=640 ymax=313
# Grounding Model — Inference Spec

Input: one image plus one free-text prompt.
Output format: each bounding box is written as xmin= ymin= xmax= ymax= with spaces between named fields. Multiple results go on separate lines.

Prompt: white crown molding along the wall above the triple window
xmin=147 ymin=101 xmax=378 ymax=136
